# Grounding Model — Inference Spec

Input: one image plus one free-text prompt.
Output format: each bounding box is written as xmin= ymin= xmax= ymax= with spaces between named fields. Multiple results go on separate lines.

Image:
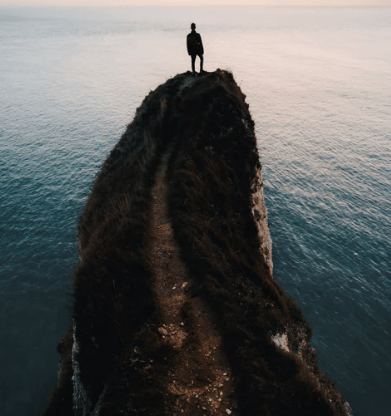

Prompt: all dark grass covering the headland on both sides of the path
xmin=45 ymin=70 xmax=350 ymax=415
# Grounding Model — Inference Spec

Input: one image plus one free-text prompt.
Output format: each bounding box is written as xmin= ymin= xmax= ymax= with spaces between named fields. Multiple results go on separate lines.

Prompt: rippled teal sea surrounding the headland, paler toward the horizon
xmin=0 ymin=8 xmax=391 ymax=416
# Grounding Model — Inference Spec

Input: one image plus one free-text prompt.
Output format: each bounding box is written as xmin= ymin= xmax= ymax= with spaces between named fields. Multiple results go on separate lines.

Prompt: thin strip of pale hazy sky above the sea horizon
xmin=0 ymin=0 xmax=391 ymax=7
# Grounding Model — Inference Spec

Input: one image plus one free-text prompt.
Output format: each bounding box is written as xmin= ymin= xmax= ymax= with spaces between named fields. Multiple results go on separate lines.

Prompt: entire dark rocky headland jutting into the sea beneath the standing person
xmin=45 ymin=70 xmax=350 ymax=416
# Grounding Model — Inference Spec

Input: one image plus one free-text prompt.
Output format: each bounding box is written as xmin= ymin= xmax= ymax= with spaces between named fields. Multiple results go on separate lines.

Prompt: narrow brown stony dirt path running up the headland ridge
xmin=149 ymin=150 xmax=235 ymax=416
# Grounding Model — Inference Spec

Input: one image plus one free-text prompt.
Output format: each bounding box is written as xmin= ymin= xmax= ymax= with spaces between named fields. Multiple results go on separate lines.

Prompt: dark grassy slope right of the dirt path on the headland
xmin=165 ymin=72 xmax=350 ymax=415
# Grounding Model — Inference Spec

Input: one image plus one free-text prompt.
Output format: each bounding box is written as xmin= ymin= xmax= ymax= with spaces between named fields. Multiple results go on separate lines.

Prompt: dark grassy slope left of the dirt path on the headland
xmin=44 ymin=75 xmax=179 ymax=415
